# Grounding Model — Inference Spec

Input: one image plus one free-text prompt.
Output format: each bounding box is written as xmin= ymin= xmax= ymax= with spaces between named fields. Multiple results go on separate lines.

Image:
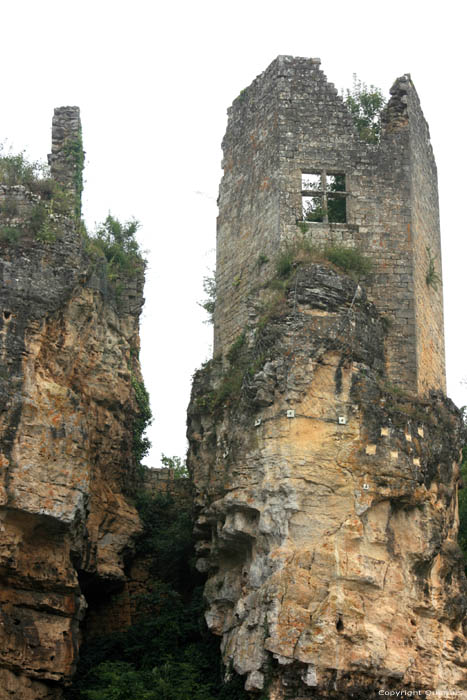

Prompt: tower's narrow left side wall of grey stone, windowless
xmin=214 ymin=65 xmax=280 ymax=352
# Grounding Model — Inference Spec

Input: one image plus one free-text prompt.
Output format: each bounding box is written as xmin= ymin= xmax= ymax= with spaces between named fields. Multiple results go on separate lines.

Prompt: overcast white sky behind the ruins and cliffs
xmin=0 ymin=0 xmax=467 ymax=466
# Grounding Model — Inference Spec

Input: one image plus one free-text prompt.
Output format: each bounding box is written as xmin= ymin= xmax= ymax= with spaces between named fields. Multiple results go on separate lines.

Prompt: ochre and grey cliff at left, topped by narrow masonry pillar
xmin=0 ymin=108 xmax=143 ymax=700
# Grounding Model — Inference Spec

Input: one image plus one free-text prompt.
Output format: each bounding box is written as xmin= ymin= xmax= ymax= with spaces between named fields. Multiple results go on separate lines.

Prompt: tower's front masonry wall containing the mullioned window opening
xmin=278 ymin=57 xmax=416 ymax=387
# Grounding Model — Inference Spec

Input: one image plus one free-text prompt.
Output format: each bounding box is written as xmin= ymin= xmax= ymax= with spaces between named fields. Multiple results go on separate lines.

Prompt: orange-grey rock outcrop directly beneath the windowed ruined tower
xmin=188 ymin=263 xmax=467 ymax=700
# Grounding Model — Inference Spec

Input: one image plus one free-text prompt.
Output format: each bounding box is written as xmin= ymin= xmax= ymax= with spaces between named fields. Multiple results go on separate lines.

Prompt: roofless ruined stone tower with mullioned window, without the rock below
xmin=215 ymin=56 xmax=445 ymax=394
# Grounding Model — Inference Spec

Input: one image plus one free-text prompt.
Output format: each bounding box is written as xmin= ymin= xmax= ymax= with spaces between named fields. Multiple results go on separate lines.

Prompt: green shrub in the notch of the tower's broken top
xmin=343 ymin=73 xmax=386 ymax=143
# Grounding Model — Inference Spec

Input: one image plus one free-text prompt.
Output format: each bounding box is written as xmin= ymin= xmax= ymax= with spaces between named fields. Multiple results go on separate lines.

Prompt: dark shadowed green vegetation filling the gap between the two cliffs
xmin=65 ymin=486 xmax=248 ymax=700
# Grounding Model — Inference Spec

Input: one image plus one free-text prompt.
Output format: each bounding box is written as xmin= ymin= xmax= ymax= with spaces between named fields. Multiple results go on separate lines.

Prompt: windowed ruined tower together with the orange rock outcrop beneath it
xmin=188 ymin=56 xmax=467 ymax=700
